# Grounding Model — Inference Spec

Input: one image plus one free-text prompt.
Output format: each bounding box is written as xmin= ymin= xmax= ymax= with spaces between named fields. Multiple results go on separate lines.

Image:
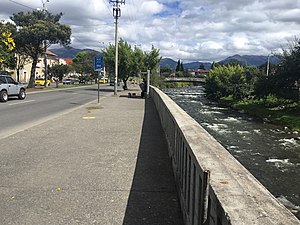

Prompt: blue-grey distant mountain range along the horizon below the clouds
xmin=49 ymin=47 xmax=279 ymax=70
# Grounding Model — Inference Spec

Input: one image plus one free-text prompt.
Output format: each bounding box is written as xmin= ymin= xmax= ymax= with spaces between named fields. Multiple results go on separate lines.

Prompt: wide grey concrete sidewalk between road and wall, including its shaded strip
xmin=0 ymin=92 xmax=183 ymax=225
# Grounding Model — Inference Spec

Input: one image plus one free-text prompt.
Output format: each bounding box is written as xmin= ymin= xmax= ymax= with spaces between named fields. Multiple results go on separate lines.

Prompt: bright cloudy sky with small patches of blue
xmin=0 ymin=0 xmax=300 ymax=62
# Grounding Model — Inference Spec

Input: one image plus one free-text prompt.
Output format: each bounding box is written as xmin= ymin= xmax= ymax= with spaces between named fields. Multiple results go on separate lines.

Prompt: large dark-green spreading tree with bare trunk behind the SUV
xmin=11 ymin=10 xmax=71 ymax=88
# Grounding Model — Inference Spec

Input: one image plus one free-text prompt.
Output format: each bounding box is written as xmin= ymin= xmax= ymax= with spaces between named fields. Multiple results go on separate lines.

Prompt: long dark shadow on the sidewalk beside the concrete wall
xmin=123 ymin=99 xmax=183 ymax=225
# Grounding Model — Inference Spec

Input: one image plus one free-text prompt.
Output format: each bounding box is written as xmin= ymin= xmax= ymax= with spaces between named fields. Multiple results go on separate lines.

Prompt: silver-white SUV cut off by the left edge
xmin=0 ymin=74 xmax=26 ymax=102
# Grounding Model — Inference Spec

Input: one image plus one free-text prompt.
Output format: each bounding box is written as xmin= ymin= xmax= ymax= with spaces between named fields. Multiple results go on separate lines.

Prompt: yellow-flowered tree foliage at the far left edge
xmin=0 ymin=22 xmax=16 ymax=69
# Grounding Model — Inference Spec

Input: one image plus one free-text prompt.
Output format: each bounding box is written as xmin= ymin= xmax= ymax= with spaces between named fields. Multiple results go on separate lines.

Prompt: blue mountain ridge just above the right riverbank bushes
xmin=218 ymin=55 xmax=279 ymax=66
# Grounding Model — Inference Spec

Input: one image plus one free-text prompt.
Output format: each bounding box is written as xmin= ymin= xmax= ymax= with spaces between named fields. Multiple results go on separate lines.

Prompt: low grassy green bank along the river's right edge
xmin=221 ymin=98 xmax=300 ymax=132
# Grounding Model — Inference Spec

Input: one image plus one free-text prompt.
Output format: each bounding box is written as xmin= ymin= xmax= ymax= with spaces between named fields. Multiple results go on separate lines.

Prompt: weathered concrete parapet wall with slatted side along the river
xmin=150 ymin=87 xmax=300 ymax=225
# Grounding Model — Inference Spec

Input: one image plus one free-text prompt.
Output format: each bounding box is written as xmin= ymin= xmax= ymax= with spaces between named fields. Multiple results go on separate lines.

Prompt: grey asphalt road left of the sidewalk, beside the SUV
xmin=0 ymin=85 xmax=113 ymax=139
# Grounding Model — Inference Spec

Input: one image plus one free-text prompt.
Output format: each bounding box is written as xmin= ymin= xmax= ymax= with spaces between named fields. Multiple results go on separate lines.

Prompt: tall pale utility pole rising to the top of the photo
xmin=109 ymin=0 xmax=125 ymax=95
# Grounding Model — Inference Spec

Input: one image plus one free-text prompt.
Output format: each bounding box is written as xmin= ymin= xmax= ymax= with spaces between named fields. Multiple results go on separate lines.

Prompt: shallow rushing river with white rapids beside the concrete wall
xmin=164 ymin=86 xmax=300 ymax=219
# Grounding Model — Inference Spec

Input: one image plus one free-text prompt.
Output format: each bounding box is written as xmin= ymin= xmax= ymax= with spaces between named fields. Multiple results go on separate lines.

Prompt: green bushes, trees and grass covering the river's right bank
xmin=205 ymin=39 xmax=300 ymax=131
